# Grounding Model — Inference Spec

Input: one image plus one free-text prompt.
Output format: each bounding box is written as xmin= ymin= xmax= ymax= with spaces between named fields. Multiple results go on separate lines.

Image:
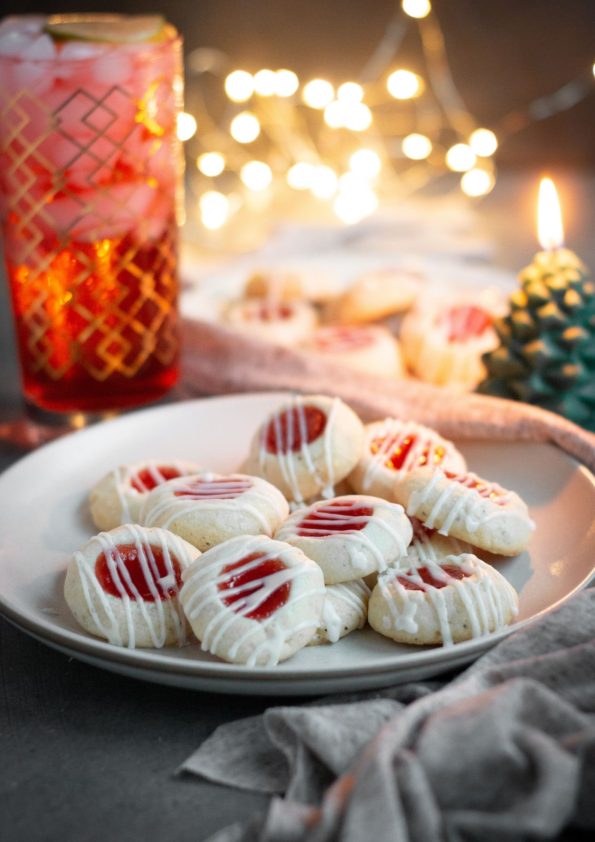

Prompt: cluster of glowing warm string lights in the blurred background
xmin=184 ymin=0 xmax=595 ymax=229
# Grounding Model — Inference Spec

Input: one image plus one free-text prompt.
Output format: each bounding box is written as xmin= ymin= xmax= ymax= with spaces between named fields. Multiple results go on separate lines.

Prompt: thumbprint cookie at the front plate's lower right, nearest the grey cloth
xmin=368 ymin=554 xmax=518 ymax=646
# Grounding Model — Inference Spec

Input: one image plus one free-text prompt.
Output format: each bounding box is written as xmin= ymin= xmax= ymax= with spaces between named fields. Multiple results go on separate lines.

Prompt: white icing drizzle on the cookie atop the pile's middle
xmin=276 ymin=495 xmax=407 ymax=571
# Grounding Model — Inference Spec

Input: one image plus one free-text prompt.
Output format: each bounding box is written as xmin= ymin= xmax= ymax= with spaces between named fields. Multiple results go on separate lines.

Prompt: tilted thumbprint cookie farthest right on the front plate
xmin=394 ymin=468 xmax=535 ymax=555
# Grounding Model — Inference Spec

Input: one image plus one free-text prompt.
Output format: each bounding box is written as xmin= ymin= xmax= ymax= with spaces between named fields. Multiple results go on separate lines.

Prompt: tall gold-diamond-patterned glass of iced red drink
xmin=0 ymin=16 xmax=182 ymax=412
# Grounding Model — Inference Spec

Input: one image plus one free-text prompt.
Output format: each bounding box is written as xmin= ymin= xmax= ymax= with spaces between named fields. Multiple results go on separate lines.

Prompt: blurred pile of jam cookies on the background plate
xmin=221 ymin=266 xmax=503 ymax=391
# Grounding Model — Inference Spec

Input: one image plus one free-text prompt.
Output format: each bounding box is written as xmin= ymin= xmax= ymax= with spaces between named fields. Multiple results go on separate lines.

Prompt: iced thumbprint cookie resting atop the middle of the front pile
xmin=275 ymin=494 xmax=412 ymax=585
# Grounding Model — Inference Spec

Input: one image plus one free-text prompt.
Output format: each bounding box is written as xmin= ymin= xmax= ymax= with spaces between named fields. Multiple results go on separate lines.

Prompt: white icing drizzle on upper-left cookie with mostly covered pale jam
xmin=141 ymin=471 xmax=287 ymax=534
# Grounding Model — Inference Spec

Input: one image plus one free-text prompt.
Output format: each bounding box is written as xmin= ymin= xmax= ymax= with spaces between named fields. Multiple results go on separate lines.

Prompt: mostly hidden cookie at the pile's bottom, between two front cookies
xmin=308 ymin=579 xmax=371 ymax=646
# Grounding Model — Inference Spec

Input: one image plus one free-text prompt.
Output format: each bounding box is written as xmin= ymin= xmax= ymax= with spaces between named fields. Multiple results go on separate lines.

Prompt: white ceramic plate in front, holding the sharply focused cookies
xmin=0 ymin=394 xmax=595 ymax=695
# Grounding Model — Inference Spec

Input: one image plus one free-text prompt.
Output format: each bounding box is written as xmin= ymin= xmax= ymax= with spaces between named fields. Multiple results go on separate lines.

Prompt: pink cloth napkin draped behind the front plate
xmin=181 ymin=321 xmax=595 ymax=471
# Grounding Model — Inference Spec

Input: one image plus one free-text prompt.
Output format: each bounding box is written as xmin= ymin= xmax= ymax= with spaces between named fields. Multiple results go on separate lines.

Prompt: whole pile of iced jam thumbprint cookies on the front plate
xmin=65 ymin=395 xmax=533 ymax=666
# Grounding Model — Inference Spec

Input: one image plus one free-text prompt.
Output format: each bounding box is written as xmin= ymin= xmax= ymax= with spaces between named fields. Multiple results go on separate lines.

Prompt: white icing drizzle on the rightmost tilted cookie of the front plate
xmin=407 ymin=468 xmax=529 ymax=535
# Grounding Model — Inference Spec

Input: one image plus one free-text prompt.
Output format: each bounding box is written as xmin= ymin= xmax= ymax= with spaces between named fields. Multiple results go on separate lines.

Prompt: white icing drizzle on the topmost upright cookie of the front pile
xmin=258 ymin=395 xmax=338 ymax=504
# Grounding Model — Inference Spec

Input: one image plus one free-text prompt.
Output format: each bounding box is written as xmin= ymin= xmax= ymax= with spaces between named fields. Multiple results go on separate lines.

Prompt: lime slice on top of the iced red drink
xmin=44 ymin=15 xmax=170 ymax=44
